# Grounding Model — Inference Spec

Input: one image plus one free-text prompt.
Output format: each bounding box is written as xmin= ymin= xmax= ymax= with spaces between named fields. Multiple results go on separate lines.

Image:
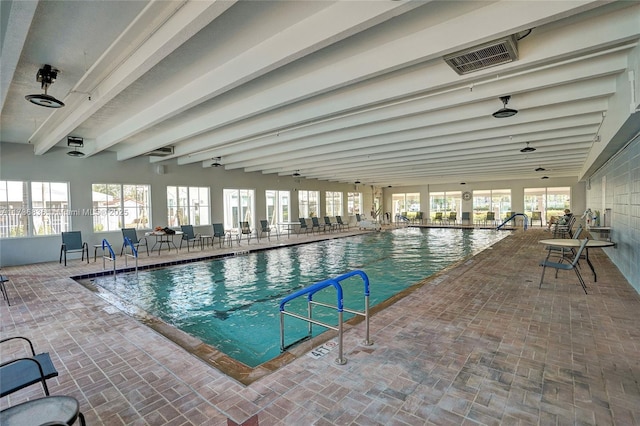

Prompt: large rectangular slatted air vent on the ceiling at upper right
xmin=444 ymin=36 xmax=518 ymax=75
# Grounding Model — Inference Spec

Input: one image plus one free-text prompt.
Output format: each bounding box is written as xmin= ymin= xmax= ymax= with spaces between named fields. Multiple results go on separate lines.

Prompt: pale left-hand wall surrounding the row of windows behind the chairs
xmin=0 ymin=143 xmax=364 ymax=266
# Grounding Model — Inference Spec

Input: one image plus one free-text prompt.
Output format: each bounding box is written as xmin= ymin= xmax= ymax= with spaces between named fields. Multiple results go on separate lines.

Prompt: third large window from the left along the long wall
xmin=167 ymin=186 xmax=211 ymax=226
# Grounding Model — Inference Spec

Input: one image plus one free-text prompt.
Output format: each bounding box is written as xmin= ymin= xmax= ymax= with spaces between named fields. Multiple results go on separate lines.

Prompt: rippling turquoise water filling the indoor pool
xmin=94 ymin=228 xmax=509 ymax=367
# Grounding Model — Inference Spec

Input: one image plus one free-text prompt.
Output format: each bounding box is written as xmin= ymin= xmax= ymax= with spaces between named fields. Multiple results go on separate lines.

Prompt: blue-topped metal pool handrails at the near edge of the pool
xmin=280 ymin=270 xmax=373 ymax=365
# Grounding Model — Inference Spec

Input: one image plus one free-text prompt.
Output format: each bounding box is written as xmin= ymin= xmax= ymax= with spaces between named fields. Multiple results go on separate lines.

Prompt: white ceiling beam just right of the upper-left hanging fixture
xmin=29 ymin=1 xmax=233 ymax=155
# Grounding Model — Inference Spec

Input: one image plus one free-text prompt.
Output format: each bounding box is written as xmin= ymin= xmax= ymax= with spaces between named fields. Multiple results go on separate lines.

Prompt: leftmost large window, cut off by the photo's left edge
xmin=0 ymin=181 xmax=69 ymax=238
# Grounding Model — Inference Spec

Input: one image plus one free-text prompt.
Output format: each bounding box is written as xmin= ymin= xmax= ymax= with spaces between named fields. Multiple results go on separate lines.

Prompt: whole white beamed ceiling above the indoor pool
xmin=0 ymin=0 xmax=640 ymax=186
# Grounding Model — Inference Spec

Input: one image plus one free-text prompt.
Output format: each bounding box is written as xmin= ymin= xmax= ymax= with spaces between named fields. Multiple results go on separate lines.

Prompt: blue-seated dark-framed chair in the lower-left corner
xmin=0 ymin=336 xmax=58 ymax=397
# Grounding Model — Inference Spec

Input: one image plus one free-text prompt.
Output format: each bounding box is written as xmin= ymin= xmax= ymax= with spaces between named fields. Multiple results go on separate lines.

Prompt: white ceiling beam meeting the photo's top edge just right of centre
xmin=97 ymin=2 xmax=419 ymax=160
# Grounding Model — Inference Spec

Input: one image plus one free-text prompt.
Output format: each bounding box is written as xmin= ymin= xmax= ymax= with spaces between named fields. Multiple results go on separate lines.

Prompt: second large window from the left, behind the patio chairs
xmin=91 ymin=183 xmax=151 ymax=232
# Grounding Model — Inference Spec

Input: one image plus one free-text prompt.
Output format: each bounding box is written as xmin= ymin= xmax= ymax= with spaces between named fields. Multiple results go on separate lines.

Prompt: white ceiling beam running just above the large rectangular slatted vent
xmin=125 ymin=1 xmax=608 ymax=160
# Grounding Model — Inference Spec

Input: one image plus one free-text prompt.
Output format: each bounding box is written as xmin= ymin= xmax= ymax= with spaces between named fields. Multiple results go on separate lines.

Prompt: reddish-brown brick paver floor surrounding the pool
xmin=0 ymin=229 xmax=640 ymax=426
